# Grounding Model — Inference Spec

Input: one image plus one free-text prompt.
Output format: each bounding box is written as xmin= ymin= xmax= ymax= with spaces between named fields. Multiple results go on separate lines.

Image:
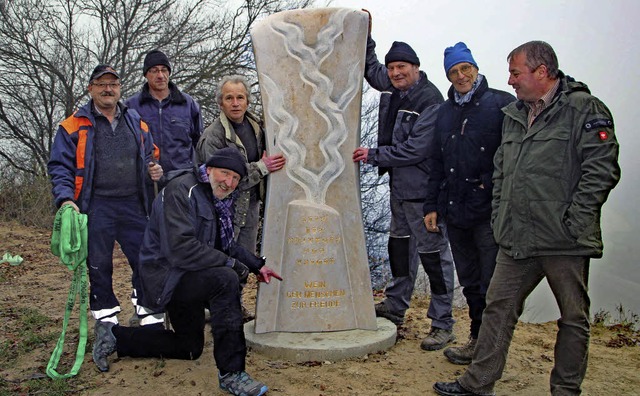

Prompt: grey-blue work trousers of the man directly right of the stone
xmin=385 ymin=197 xmax=455 ymax=330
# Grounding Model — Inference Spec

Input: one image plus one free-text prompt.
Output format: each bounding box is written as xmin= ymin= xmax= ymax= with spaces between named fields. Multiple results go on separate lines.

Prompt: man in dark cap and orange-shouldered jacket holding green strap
xmin=47 ymin=64 xmax=163 ymax=368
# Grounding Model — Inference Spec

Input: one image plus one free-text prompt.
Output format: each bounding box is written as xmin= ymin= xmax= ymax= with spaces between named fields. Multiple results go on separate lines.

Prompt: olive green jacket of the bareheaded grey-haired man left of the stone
xmin=196 ymin=112 xmax=269 ymax=230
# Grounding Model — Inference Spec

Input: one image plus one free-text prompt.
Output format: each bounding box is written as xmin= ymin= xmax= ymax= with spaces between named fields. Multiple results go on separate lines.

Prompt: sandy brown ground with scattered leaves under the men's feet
xmin=0 ymin=224 xmax=640 ymax=395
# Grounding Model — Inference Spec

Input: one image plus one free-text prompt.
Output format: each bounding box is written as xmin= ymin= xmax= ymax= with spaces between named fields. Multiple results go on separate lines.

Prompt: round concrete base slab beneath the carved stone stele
xmin=244 ymin=318 xmax=397 ymax=363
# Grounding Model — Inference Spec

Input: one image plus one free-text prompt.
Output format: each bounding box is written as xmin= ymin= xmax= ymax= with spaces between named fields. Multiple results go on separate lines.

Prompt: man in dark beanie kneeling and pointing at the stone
xmin=94 ymin=147 xmax=282 ymax=396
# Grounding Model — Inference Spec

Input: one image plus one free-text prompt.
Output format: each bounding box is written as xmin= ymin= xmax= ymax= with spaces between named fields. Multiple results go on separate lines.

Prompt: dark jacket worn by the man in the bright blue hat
xmin=424 ymin=78 xmax=516 ymax=228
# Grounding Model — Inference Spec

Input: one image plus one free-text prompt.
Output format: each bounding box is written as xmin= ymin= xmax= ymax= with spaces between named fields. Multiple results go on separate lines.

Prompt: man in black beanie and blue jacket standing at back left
xmin=125 ymin=50 xmax=203 ymax=192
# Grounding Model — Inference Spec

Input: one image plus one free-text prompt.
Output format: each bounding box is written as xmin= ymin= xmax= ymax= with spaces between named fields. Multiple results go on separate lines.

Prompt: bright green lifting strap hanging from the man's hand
xmin=47 ymin=205 xmax=89 ymax=379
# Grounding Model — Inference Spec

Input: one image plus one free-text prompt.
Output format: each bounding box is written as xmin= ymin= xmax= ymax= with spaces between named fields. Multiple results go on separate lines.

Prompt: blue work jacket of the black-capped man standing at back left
xmin=125 ymin=82 xmax=202 ymax=174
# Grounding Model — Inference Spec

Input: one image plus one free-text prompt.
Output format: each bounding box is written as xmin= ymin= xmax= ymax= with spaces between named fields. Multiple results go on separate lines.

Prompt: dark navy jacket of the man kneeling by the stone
xmin=138 ymin=169 xmax=264 ymax=311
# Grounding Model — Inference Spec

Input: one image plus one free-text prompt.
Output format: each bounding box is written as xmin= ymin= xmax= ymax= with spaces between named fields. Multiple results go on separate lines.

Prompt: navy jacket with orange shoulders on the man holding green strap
xmin=47 ymin=101 xmax=154 ymax=213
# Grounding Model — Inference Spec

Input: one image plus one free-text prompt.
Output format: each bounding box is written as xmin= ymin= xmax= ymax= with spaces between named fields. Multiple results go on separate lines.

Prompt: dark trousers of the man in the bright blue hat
xmin=447 ymin=220 xmax=498 ymax=338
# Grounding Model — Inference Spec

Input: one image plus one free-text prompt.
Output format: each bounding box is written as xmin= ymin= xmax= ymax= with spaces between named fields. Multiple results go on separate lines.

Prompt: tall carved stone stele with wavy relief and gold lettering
xmin=245 ymin=8 xmax=395 ymax=355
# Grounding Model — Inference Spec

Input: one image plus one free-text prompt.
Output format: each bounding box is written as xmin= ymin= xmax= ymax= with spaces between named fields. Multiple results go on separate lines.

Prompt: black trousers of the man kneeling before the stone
xmin=113 ymin=267 xmax=247 ymax=372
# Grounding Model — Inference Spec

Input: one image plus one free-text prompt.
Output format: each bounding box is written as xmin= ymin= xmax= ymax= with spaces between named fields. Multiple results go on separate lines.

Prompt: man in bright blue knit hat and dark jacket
xmin=424 ymin=42 xmax=516 ymax=364
